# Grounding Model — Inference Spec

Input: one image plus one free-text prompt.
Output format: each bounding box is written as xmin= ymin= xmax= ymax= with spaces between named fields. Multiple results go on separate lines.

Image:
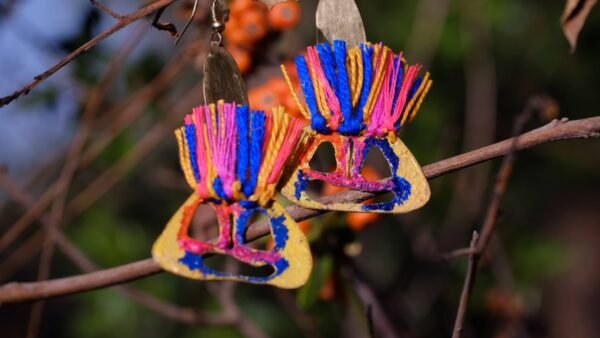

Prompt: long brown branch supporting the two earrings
xmin=0 ymin=116 xmax=600 ymax=303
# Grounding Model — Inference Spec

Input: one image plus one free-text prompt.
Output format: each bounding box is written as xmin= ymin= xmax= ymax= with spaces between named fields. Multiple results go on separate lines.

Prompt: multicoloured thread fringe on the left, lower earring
xmin=175 ymin=101 xmax=306 ymax=206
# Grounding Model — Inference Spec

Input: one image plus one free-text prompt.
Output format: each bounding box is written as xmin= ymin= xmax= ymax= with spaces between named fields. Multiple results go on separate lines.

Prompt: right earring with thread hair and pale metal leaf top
xmin=282 ymin=0 xmax=431 ymax=213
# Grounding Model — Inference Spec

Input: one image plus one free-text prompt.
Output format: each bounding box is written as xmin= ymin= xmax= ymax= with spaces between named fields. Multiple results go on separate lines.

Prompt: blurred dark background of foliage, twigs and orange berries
xmin=0 ymin=0 xmax=600 ymax=338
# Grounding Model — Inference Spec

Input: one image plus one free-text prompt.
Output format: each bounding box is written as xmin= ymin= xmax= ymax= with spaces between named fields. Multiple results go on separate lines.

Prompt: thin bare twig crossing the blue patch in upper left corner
xmin=0 ymin=0 xmax=175 ymax=108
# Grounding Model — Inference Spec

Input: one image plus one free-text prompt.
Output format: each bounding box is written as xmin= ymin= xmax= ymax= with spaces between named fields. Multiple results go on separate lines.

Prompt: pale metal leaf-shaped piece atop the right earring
xmin=317 ymin=0 xmax=367 ymax=48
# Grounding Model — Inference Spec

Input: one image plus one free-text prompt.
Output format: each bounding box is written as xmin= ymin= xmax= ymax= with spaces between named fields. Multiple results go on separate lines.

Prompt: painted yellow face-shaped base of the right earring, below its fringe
xmin=282 ymin=134 xmax=430 ymax=213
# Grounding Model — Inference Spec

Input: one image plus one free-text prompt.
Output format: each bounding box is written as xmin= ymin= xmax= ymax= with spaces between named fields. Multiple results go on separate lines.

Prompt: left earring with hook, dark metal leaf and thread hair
xmin=152 ymin=0 xmax=312 ymax=288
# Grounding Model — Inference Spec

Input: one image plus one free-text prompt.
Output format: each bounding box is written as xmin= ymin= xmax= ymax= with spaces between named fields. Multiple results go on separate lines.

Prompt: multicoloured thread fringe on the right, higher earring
xmin=282 ymin=40 xmax=432 ymax=138
